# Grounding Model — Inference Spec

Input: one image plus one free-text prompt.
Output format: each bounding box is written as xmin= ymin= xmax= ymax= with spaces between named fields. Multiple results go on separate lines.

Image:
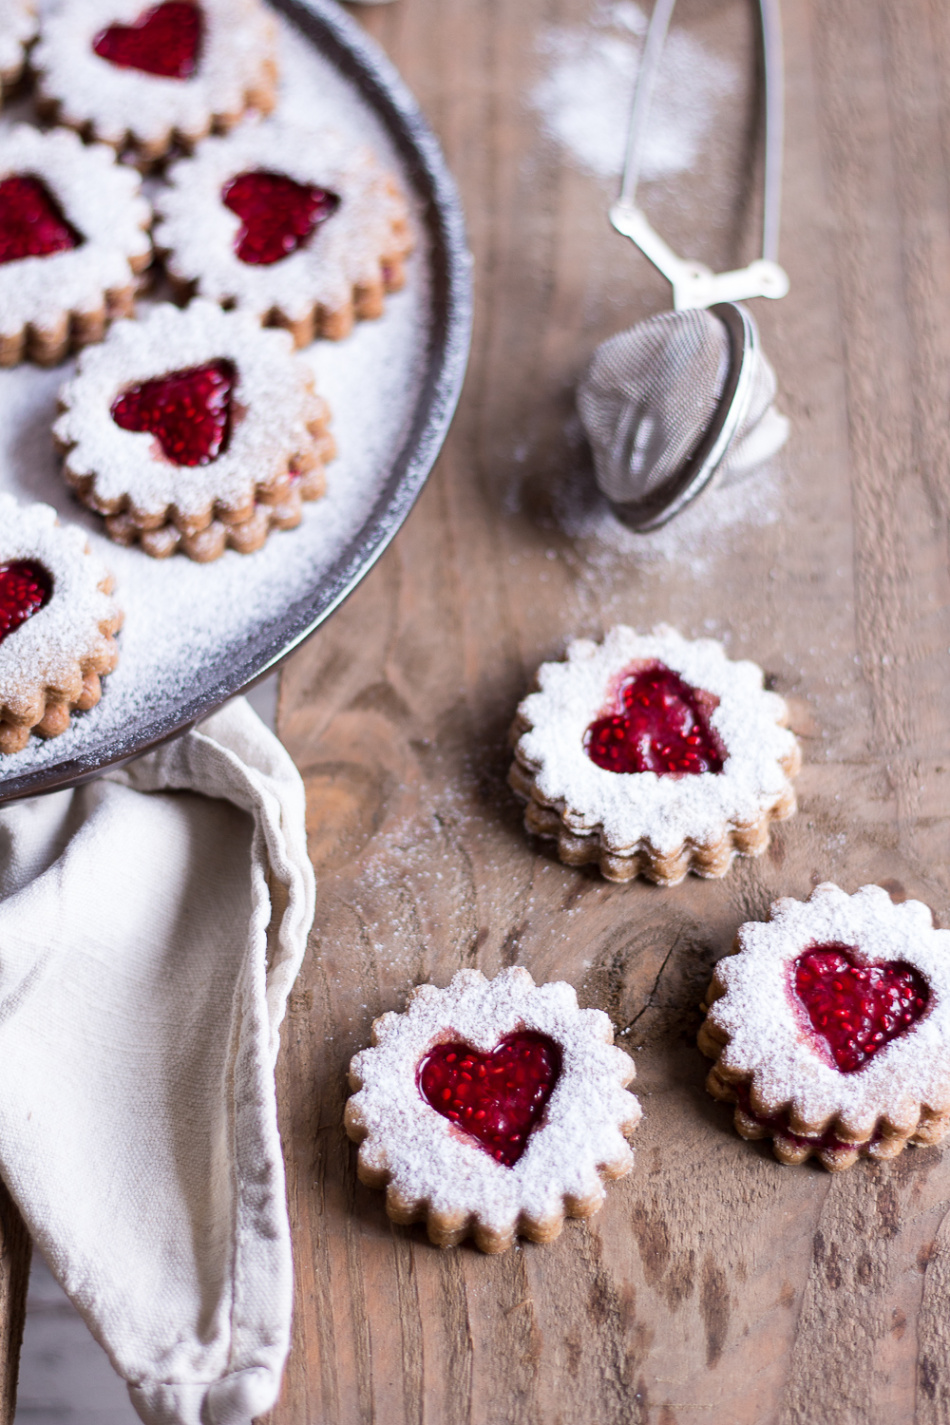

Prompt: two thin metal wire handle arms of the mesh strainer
xmin=620 ymin=0 xmax=785 ymax=262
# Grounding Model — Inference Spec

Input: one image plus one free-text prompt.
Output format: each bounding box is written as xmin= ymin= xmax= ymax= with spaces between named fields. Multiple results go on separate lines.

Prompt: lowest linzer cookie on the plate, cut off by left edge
xmin=0 ymin=494 xmax=122 ymax=754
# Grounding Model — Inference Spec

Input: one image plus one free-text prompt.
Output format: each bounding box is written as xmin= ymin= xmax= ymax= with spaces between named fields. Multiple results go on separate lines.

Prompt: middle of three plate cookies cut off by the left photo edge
xmin=0 ymin=124 xmax=151 ymax=366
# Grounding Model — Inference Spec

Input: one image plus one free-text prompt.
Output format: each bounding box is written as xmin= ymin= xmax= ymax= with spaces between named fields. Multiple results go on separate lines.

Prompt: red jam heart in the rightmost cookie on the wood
xmin=792 ymin=942 xmax=930 ymax=1073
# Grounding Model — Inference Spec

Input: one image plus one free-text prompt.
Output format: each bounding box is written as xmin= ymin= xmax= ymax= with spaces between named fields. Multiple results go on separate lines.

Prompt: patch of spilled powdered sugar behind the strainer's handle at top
xmin=528 ymin=0 xmax=735 ymax=180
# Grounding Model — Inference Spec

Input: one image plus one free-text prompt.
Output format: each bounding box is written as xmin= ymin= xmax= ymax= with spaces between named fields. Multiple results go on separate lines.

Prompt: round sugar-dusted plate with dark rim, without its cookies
xmin=0 ymin=0 xmax=471 ymax=802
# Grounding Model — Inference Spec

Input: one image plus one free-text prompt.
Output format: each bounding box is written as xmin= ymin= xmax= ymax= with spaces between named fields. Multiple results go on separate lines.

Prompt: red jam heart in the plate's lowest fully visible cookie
xmin=113 ymin=361 xmax=235 ymax=466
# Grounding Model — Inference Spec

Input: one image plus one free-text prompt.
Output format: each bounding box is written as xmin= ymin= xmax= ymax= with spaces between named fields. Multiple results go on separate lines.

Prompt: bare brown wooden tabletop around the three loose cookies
xmin=262 ymin=0 xmax=950 ymax=1425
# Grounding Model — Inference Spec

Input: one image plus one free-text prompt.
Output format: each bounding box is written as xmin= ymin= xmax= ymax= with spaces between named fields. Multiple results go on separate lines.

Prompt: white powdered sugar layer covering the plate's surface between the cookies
xmin=0 ymin=8 xmax=430 ymax=785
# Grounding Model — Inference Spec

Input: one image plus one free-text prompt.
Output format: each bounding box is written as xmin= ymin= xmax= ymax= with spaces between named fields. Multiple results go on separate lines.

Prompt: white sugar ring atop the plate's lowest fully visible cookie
xmin=54 ymin=299 xmax=323 ymax=516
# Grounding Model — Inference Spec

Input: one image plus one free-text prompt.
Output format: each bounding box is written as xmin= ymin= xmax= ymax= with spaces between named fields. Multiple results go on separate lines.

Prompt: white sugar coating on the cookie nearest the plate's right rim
xmin=155 ymin=120 xmax=406 ymax=321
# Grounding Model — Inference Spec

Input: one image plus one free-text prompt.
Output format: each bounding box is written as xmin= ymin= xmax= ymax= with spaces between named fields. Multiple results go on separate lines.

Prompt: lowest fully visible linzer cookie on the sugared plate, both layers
xmin=53 ymin=301 xmax=333 ymax=561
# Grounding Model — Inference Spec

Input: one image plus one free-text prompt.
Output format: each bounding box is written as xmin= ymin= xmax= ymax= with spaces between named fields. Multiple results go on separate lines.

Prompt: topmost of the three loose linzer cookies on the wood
xmin=508 ymin=624 xmax=800 ymax=885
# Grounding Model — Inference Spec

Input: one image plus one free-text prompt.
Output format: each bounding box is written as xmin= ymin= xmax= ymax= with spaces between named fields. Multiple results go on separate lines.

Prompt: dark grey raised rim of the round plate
xmin=0 ymin=0 xmax=471 ymax=802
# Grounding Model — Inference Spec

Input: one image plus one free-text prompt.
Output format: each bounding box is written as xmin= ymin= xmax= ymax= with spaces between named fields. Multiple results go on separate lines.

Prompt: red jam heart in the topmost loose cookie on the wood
xmin=584 ymin=663 xmax=726 ymax=777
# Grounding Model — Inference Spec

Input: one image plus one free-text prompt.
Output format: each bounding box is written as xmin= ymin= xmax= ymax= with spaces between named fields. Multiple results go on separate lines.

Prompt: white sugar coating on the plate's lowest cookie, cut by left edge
xmin=0 ymin=494 xmax=118 ymax=715
